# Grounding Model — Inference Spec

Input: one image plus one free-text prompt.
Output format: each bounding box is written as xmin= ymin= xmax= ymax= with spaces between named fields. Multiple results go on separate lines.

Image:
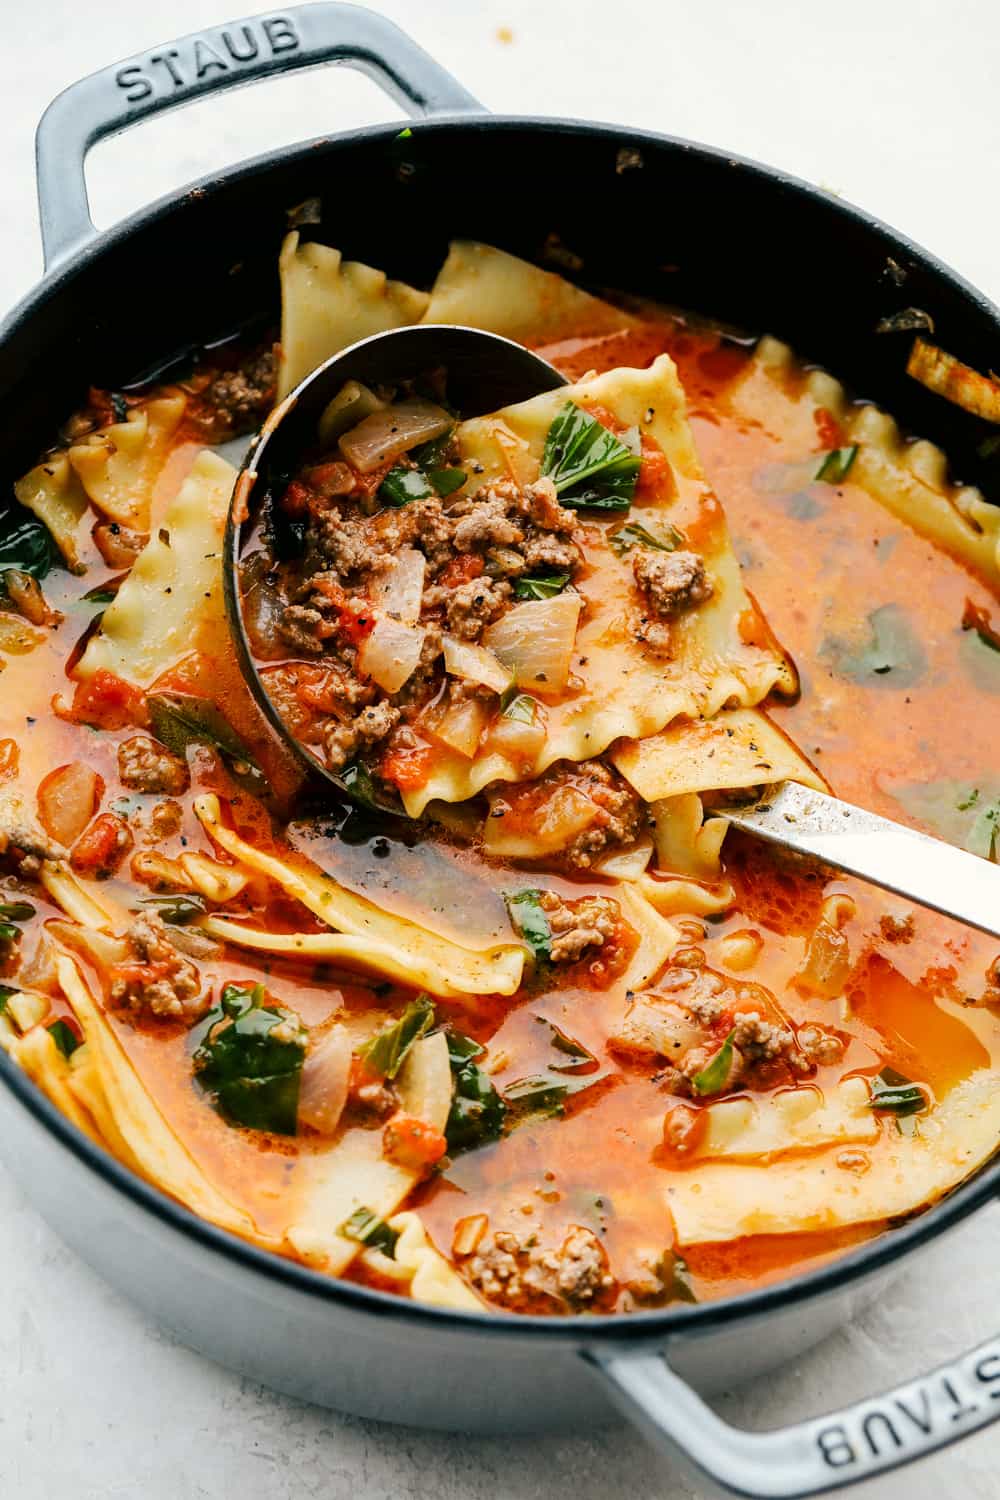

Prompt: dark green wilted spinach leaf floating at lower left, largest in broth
xmin=193 ymin=984 xmax=307 ymax=1136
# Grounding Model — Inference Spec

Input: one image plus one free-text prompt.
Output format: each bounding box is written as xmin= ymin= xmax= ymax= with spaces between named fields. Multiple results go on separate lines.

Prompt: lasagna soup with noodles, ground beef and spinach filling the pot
xmin=0 ymin=233 xmax=1000 ymax=1316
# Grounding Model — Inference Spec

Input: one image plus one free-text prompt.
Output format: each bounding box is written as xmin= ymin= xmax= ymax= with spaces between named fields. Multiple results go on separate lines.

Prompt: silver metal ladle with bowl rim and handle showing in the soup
xmin=223 ymin=324 xmax=1000 ymax=938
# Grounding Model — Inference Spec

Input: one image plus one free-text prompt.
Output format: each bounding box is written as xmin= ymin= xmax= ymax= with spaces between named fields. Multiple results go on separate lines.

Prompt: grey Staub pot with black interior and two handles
xmin=0 ymin=3 xmax=1000 ymax=1497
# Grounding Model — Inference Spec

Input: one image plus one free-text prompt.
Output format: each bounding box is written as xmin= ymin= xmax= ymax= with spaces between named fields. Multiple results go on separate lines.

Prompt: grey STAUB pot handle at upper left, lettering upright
xmin=34 ymin=0 xmax=483 ymax=270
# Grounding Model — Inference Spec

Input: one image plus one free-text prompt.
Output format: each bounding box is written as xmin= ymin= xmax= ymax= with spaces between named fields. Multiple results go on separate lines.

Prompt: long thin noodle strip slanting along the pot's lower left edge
xmin=55 ymin=956 xmax=261 ymax=1241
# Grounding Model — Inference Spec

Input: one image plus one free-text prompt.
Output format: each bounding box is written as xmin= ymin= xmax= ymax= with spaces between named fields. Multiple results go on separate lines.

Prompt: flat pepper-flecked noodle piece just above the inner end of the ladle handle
xmin=610 ymin=708 xmax=826 ymax=803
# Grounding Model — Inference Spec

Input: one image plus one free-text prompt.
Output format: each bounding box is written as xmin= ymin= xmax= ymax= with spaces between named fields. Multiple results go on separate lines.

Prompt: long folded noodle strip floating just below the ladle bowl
xmin=195 ymin=795 xmax=525 ymax=996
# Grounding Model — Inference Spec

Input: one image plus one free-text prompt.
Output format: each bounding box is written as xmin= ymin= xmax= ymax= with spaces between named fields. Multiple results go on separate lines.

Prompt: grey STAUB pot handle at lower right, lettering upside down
xmin=583 ymin=1338 xmax=1000 ymax=1500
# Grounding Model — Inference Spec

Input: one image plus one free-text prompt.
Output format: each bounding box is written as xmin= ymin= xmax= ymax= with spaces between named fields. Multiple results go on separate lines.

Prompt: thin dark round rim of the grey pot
xmin=0 ymin=114 xmax=1000 ymax=1347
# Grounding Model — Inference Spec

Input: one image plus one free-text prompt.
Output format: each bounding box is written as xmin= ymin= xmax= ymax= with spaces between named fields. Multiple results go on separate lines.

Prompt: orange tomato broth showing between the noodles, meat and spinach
xmin=3 ymin=318 xmax=1000 ymax=1298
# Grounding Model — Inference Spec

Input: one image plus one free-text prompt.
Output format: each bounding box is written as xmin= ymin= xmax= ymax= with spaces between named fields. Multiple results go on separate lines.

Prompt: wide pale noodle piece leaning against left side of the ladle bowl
xmin=73 ymin=452 xmax=235 ymax=687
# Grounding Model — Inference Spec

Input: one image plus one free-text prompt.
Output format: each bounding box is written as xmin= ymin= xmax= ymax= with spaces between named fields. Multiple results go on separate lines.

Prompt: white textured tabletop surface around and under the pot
xmin=0 ymin=0 xmax=1000 ymax=1500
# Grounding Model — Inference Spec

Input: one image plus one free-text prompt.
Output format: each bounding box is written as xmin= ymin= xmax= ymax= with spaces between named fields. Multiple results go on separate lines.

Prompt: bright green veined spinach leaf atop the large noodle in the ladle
xmin=541 ymin=401 xmax=642 ymax=510
